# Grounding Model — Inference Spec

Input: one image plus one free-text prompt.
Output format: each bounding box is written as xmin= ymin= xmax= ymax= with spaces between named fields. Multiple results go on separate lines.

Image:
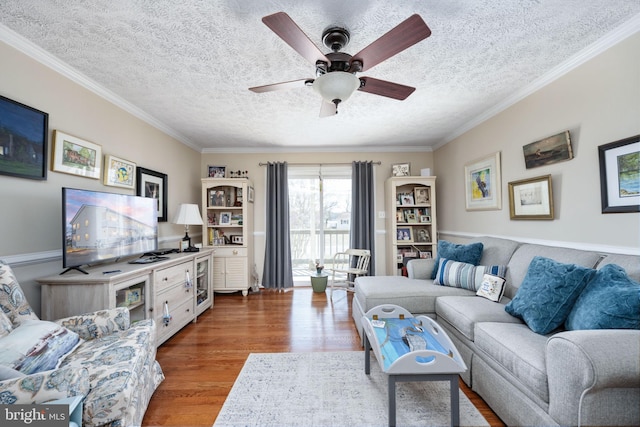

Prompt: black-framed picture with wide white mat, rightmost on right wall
xmin=598 ymin=135 xmax=640 ymax=213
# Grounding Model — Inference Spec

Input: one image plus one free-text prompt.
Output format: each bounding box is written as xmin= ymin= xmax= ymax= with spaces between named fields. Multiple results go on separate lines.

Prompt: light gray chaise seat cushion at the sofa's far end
xmin=354 ymin=276 xmax=475 ymax=315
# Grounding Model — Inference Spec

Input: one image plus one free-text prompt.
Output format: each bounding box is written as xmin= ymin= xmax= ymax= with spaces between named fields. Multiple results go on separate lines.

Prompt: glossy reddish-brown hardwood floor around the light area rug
xmin=143 ymin=287 xmax=504 ymax=427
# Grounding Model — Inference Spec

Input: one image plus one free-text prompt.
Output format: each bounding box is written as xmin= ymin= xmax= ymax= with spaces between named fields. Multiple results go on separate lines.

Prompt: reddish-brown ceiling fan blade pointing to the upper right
xmin=351 ymin=14 xmax=431 ymax=71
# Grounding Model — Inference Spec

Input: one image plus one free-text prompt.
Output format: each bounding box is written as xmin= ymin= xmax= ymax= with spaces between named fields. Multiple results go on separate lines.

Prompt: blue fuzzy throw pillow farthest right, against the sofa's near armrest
xmin=564 ymin=264 xmax=640 ymax=330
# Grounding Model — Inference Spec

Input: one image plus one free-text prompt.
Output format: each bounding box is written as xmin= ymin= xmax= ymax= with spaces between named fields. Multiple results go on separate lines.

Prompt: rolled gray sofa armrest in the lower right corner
xmin=546 ymin=329 xmax=640 ymax=425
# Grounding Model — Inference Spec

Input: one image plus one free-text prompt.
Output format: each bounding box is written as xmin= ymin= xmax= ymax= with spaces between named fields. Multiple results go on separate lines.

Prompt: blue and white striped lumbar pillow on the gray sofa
xmin=433 ymin=258 xmax=507 ymax=291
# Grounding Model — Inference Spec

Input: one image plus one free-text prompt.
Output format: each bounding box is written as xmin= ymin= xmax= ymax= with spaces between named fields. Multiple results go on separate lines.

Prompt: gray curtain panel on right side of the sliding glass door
xmin=349 ymin=162 xmax=376 ymax=276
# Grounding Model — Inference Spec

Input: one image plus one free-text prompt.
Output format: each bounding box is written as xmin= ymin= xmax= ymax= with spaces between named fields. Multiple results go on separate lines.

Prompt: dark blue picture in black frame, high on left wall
xmin=0 ymin=96 xmax=49 ymax=180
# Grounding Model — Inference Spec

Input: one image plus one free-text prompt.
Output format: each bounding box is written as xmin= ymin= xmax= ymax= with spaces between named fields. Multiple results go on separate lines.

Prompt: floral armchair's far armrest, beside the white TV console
xmin=56 ymin=307 xmax=131 ymax=340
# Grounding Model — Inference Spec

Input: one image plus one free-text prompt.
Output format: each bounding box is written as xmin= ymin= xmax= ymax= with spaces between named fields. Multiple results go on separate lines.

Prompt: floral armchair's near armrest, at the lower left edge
xmin=0 ymin=366 xmax=90 ymax=405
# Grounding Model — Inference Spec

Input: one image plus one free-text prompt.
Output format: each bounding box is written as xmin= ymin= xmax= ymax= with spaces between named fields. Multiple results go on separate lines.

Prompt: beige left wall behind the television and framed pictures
xmin=0 ymin=43 xmax=200 ymax=309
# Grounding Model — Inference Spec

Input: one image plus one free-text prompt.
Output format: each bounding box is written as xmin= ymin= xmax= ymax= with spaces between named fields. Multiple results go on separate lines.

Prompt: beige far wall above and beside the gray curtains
xmin=201 ymin=152 xmax=433 ymax=278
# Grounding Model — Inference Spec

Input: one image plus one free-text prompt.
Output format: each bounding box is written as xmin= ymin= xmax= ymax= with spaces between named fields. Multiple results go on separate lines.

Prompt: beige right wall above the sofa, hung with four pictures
xmin=434 ymin=33 xmax=640 ymax=253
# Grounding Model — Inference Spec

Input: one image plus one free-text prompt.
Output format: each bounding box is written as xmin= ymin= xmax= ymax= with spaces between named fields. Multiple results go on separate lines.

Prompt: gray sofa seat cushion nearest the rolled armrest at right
xmin=474 ymin=322 xmax=549 ymax=403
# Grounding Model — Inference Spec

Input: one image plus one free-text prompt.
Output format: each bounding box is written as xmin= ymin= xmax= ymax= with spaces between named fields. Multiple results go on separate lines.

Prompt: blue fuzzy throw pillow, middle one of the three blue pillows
xmin=504 ymin=256 xmax=596 ymax=335
